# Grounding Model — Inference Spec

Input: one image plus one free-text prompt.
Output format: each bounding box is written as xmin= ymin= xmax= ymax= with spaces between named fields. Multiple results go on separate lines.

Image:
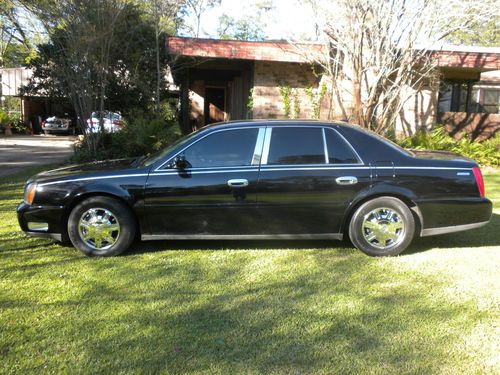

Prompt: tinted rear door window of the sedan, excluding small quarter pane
xmin=267 ymin=127 xmax=325 ymax=165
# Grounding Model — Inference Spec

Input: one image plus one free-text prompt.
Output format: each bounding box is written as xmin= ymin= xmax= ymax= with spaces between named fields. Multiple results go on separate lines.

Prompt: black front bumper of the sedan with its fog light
xmin=16 ymin=202 xmax=64 ymax=241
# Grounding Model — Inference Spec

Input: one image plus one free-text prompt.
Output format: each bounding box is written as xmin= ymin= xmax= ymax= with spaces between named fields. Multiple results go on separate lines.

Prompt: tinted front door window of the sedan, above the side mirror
xmin=184 ymin=128 xmax=259 ymax=168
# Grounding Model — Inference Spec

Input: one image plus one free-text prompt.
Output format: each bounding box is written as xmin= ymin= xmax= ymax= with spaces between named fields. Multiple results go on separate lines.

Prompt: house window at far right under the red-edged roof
xmin=438 ymin=82 xmax=500 ymax=113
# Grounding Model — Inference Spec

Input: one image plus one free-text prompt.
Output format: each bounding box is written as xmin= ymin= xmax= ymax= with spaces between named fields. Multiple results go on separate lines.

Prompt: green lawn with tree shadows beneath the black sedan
xmin=0 ymin=171 xmax=500 ymax=374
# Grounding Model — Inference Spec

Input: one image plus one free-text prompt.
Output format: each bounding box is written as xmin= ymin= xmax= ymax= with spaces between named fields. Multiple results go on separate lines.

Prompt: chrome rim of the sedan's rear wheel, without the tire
xmin=362 ymin=207 xmax=405 ymax=249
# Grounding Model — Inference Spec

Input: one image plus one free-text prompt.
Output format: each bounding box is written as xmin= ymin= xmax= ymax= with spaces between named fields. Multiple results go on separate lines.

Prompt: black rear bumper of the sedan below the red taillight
xmin=417 ymin=198 xmax=493 ymax=236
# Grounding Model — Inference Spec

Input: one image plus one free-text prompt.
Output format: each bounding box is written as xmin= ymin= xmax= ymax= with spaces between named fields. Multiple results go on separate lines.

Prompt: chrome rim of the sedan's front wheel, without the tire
xmin=78 ymin=208 xmax=120 ymax=250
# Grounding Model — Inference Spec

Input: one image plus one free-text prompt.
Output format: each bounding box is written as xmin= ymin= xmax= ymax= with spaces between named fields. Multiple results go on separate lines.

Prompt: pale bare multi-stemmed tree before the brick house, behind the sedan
xmin=300 ymin=0 xmax=494 ymax=132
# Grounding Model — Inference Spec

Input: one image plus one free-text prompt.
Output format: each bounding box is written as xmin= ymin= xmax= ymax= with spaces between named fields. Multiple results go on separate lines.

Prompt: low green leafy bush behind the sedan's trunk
xmin=398 ymin=126 xmax=500 ymax=167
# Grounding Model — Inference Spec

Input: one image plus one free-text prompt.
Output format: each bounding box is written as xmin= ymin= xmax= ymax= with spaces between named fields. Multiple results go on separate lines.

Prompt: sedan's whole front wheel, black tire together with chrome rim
xmin=68 ymin=196 xmax=137 ymax=256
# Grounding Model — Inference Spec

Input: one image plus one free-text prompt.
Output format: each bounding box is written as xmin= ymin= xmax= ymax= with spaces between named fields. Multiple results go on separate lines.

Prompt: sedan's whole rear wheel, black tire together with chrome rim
xmin=349 ymin=197 xmax=415 ymax=256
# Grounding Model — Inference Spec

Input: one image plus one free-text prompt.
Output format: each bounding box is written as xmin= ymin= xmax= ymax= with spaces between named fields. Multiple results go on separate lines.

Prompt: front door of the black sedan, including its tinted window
xmin=145 ymin=127 xmax=265 ymax=238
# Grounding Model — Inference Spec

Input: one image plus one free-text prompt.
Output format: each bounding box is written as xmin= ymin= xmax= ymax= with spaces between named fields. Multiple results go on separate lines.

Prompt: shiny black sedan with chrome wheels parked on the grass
xmin=17 ymin=121 xmax=492 ymax=256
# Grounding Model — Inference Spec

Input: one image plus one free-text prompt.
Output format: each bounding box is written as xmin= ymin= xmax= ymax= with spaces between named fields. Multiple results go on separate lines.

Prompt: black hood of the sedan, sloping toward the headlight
xmin=28 ymin=159 xmax=144 ymax=183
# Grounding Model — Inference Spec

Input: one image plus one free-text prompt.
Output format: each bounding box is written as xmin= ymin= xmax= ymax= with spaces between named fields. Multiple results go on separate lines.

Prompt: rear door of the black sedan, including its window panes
xmin=258 ymin=125 xmax=370 ymax=237
